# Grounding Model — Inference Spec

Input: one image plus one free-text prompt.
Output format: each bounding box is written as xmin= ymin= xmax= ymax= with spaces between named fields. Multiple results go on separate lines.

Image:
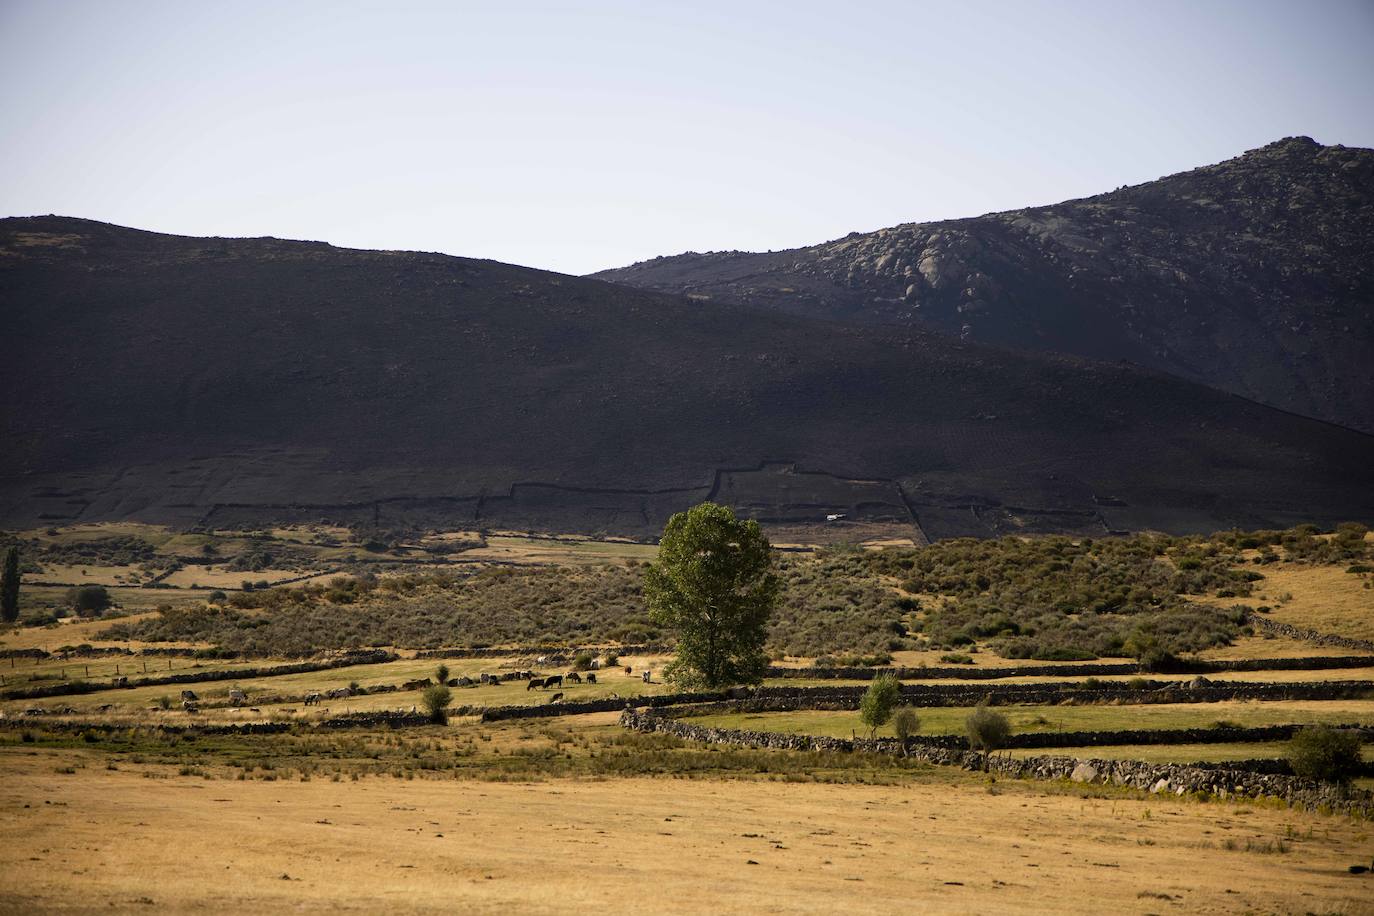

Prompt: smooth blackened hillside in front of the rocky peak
xmin=0 ymin=217 xmax=1374 ymax=537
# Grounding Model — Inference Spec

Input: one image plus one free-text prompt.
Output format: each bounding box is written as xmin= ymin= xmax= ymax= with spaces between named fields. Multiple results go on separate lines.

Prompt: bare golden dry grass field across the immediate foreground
xmin=0 ymin=750 xmax=1370 ymax=913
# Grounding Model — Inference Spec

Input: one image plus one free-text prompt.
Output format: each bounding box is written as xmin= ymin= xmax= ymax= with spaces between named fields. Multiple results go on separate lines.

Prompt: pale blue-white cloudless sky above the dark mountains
xmin=0 ymin=0 xmax=1374 ymax=273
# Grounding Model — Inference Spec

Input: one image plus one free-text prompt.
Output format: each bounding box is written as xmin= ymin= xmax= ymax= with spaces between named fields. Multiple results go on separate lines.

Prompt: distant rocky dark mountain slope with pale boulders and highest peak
xmin=596 ymin=137 xmax=1374 ymax=433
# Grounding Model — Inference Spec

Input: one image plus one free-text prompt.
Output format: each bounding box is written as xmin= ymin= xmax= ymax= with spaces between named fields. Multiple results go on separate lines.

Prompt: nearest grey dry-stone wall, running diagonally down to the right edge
xmin=620 ymin=709 xmax=1374 ymax=817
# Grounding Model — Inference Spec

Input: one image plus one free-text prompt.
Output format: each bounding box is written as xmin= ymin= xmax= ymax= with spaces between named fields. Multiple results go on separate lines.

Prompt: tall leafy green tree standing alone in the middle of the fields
xmin=644 ymin=503 xmax=780 ymax=688
